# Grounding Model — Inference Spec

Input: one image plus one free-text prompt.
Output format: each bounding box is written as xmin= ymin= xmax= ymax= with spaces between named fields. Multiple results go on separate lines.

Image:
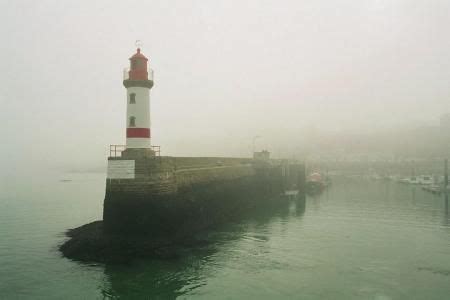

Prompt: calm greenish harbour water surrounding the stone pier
xmin=0 ymin=174 xmax=450 ymax=299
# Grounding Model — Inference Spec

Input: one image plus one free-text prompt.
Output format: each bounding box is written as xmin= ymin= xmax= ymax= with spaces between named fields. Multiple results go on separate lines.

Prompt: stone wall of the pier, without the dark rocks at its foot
xmin=103 ymin=157 xmax=304 ymax=236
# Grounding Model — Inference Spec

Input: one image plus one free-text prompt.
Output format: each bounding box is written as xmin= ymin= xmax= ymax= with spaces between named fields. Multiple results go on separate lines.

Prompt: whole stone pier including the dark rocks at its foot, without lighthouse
xmin=60 ymin=156 xmax=305 ymax=261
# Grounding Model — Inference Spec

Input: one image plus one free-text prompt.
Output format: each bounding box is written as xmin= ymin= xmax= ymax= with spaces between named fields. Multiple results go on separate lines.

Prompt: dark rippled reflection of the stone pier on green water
xmin=101 ymin=197 xmax=306 ymax=299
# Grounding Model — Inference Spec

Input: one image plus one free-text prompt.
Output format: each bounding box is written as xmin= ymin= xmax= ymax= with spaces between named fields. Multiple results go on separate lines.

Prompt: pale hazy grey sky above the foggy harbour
xmin=0 ymin=0 xmax=450 ymax=169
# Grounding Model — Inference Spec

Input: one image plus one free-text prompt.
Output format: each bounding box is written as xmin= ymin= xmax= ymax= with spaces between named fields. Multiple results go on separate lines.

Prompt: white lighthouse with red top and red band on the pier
xmin=123 ymin=48 xmax=154 ymax=154
